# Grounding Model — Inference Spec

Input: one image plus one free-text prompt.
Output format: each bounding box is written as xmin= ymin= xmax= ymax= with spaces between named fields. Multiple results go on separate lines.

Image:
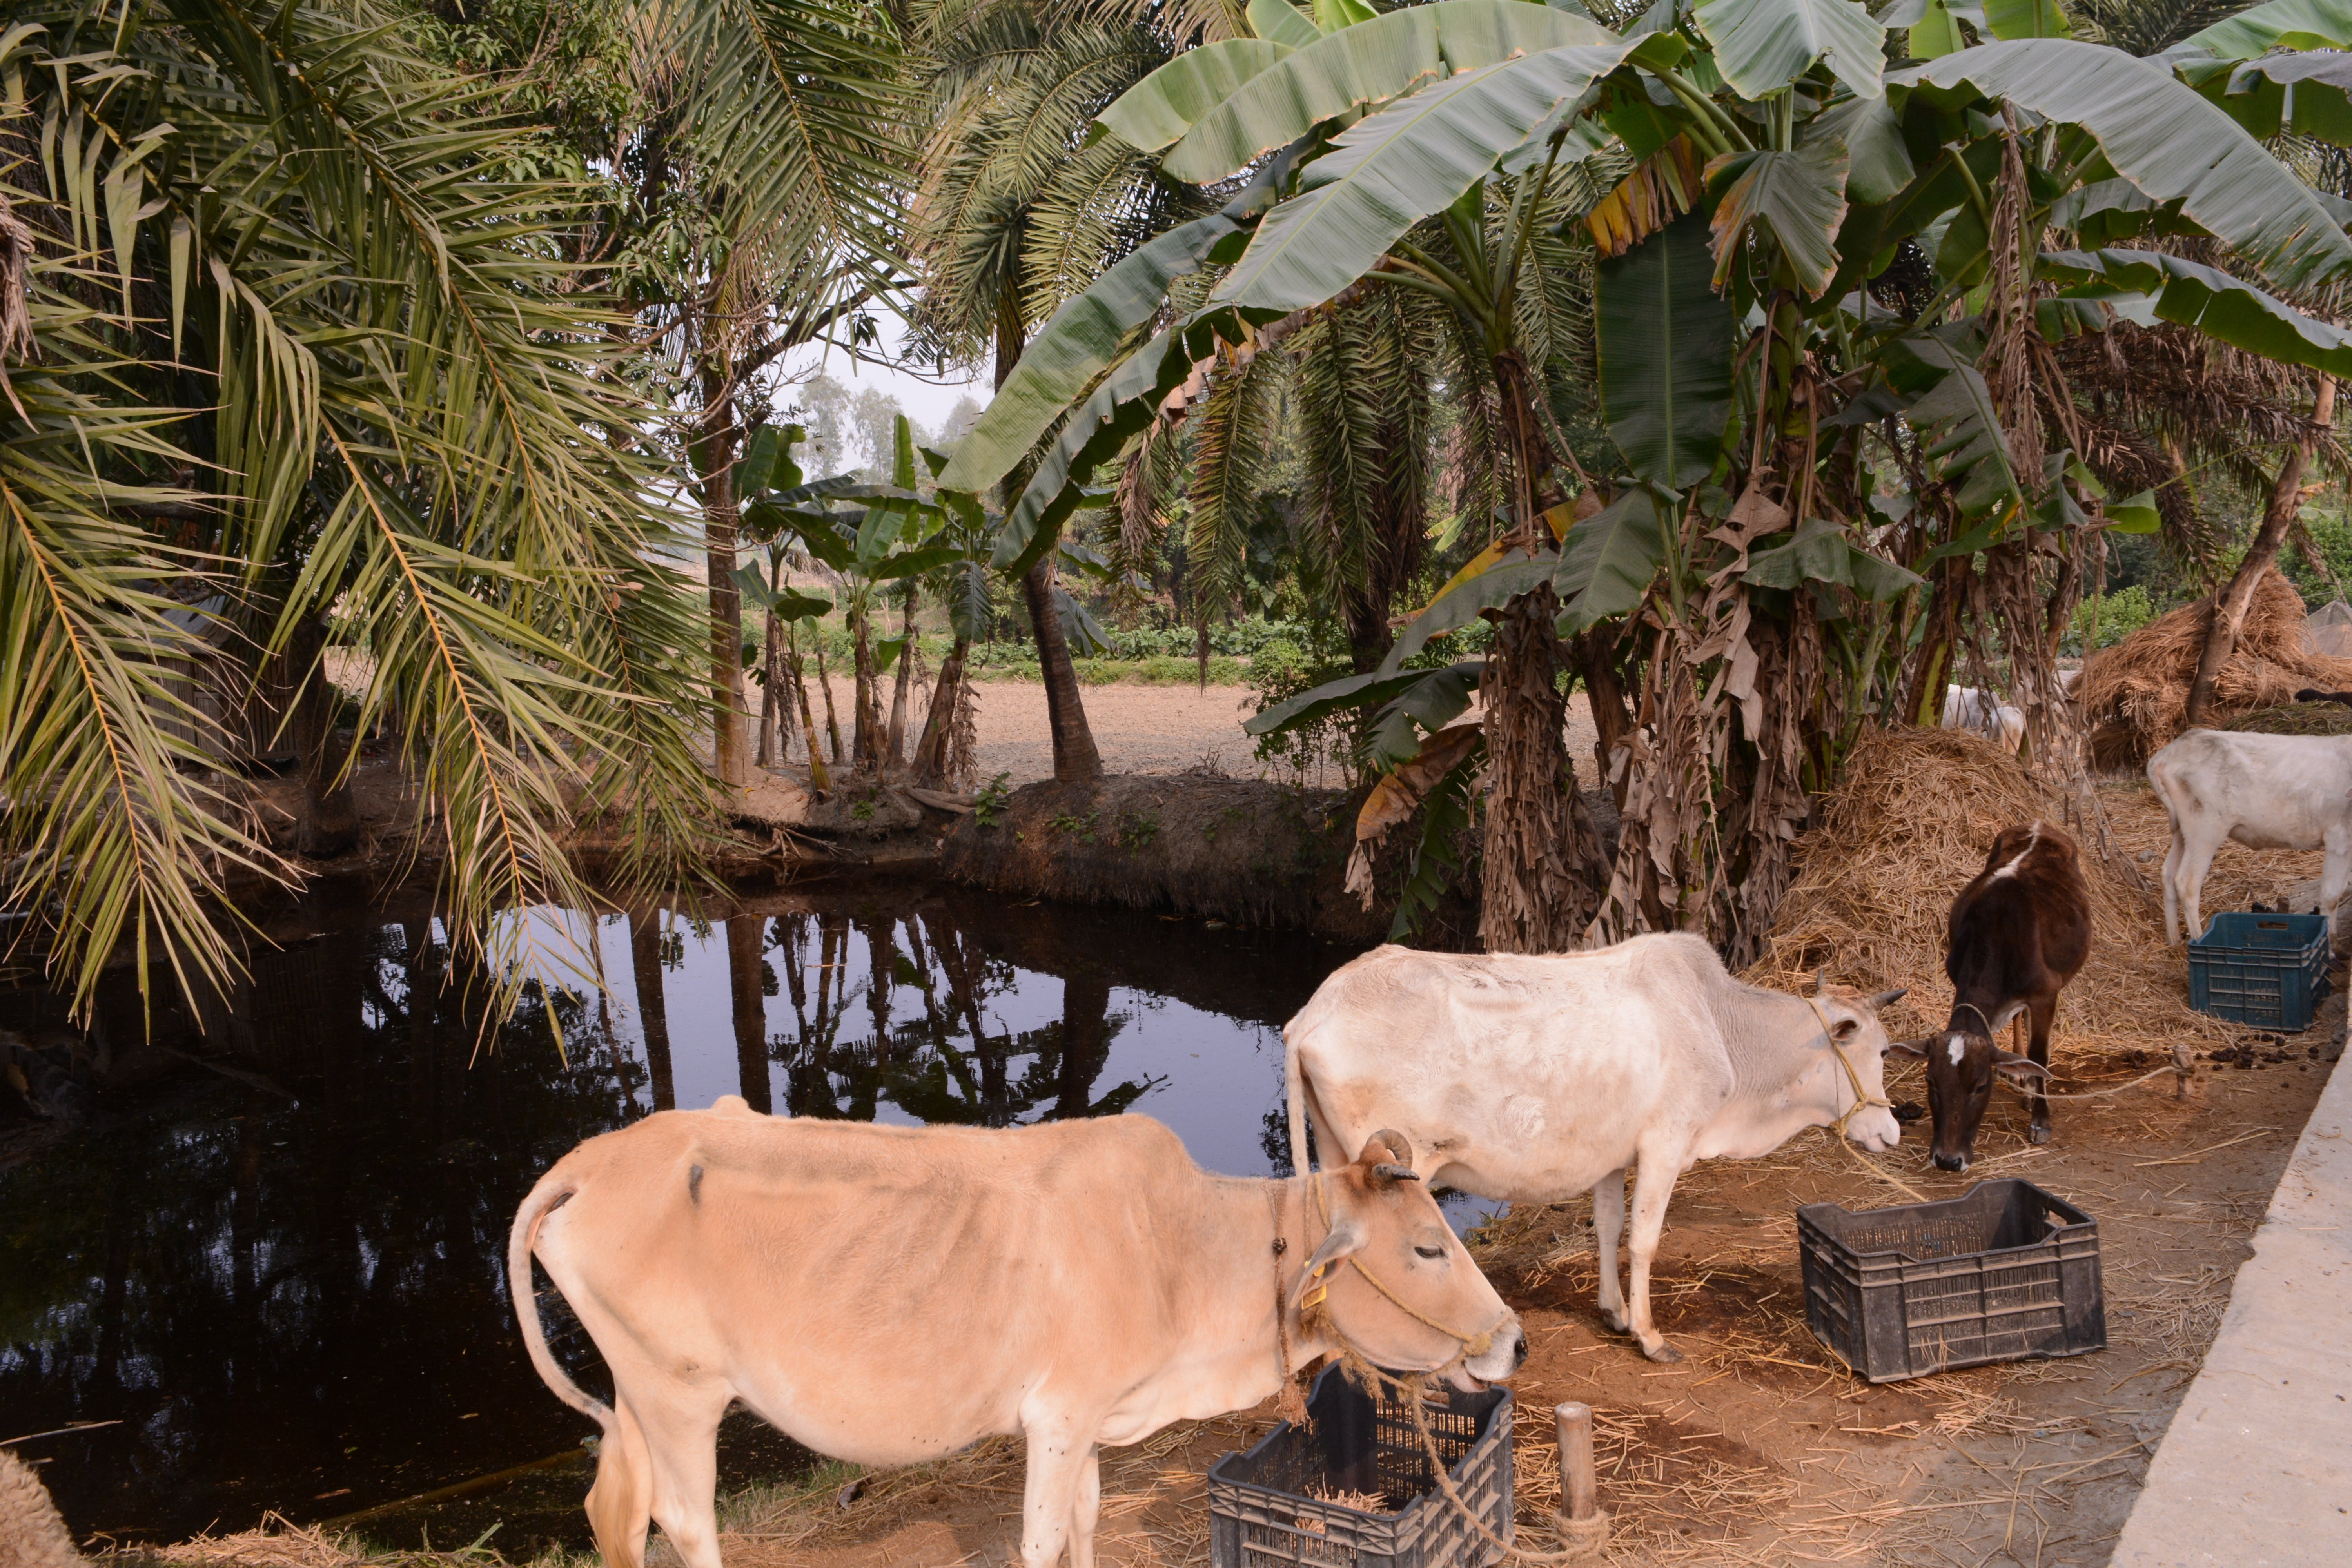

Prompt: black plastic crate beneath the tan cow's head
xmin=1209 ymin=1366 xmax=1512 ymax=1568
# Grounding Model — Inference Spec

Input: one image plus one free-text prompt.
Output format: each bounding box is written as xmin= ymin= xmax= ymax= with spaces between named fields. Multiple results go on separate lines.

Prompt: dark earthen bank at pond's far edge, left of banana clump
xmin=938 ymin=773 xmax=1477 ymax=947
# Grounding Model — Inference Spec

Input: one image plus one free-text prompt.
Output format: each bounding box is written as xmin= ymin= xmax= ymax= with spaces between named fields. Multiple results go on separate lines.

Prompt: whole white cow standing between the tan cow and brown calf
xmin=1282 ymin=933 xmax=1903 ymax=1361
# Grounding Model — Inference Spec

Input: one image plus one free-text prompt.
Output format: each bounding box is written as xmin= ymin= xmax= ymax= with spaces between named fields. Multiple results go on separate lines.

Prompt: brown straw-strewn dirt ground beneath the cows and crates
xmin=677 ymin=982 xmax=2343 ymax=1568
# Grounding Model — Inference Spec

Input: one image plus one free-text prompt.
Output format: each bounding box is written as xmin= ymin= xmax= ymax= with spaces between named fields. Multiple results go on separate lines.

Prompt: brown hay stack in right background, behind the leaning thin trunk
xmin=2074 ymin=571 xmax=2352 ymax=771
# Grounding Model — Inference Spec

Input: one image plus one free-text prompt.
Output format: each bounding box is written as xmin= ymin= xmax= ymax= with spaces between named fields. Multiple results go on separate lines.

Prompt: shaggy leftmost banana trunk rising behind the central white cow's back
xmin=1479 ymin=585 xmax=1599 ymax=952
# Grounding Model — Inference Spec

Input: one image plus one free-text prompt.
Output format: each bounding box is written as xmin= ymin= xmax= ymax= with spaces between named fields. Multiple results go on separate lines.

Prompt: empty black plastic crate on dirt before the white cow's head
xmin=1797 ymin=1178 xmax=2107 ymax=1382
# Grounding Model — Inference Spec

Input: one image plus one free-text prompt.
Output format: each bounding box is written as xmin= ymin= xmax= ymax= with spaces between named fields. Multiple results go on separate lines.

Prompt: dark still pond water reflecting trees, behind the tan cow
xmin=0 ymin=882 xmax=1475 ymax=1556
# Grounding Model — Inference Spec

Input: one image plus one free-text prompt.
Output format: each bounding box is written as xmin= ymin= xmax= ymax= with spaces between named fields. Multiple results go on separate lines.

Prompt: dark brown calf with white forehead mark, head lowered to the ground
xmin=1889 ymin=823 xmax=2091 ymax=1171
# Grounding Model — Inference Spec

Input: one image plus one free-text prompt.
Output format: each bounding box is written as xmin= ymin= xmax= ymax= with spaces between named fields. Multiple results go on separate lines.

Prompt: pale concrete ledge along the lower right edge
xmin=2112 ymin=1020 xmax=2352 ymax=1568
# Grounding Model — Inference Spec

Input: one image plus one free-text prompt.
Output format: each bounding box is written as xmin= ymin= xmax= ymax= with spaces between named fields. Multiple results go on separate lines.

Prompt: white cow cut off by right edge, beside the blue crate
xmin=2147 ymin=729 xmax=2352 ymax=947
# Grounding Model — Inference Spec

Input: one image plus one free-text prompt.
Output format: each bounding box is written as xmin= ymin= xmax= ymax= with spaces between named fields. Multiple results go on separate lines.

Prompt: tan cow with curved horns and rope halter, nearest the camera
xmin=508 ymin=1096 xmax=1526 ymax=1568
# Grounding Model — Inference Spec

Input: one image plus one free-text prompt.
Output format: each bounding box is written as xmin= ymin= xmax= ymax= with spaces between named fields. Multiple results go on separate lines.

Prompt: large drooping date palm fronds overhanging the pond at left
xmin=0 ymin=0 xmax=710 ymax=1020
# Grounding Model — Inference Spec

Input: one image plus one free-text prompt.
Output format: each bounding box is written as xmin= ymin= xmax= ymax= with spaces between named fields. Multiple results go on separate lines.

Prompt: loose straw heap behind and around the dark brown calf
xmin=1748 ymin=729 xmax=2319 ymax=1077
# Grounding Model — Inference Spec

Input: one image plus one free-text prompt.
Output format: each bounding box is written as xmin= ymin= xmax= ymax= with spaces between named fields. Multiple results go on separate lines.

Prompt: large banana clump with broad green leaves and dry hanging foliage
xmin=943 ymin=0 xmax=2352 ymax=959
